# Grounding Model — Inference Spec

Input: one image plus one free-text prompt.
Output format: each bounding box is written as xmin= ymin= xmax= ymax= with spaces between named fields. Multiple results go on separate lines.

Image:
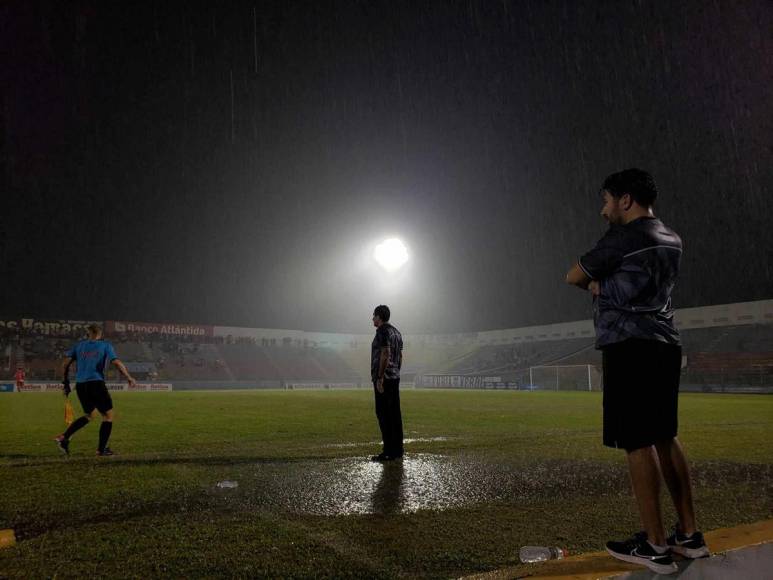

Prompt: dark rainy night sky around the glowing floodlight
xmin=0 ymin=0 xmax=773 ymax=332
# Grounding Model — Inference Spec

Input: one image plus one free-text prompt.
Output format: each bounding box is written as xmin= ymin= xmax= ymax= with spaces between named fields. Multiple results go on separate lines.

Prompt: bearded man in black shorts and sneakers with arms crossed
xmin=566 ymin=169 xmax=709 ymax=574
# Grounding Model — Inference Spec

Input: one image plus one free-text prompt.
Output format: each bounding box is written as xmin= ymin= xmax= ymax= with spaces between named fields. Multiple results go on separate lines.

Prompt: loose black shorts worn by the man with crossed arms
xmin=602 ymin=339 xmax=682 ymax=450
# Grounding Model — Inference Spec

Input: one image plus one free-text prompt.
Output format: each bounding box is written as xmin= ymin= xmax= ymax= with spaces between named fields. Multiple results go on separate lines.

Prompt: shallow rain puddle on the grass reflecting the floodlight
xmin=208 ymin=453 xmax=773 ymax=516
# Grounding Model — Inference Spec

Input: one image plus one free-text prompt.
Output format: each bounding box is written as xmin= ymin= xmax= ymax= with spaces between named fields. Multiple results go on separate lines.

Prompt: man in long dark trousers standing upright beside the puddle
xmin=370 ymin=304 xmax=403 ymax=461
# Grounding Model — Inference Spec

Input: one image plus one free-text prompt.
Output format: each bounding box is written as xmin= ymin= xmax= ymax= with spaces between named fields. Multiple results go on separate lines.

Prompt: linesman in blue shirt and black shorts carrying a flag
xmin=54 ymin=324 xmax=136 ymax=456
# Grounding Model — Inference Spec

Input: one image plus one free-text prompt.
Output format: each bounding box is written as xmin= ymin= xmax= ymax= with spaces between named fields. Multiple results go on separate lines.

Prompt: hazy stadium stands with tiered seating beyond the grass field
xmin=0 ymin=301 xmax=773 ymax=392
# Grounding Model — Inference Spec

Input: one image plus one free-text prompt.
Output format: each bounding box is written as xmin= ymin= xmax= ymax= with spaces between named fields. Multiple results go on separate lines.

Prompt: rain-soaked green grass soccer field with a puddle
xmin=0 ymin=390 xmax=773 ymax=578
